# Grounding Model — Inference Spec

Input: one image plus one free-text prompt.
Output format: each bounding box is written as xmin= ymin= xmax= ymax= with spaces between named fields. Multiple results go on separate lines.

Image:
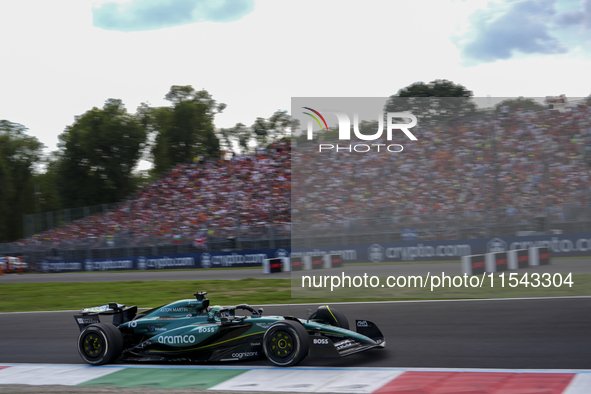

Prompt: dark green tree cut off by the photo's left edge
xmin=0 ymin=120 xmax=44 ymax=241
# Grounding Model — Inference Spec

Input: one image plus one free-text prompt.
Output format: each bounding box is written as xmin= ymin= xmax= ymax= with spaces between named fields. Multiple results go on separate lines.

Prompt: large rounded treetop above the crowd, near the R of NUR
xmin=384 ymin=79 xmax=476 ymax=125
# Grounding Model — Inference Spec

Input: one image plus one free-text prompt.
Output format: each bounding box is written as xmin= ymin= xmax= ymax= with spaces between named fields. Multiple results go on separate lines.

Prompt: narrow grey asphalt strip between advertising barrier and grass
xmin=0 ymin=259 xmax=591 ymax=284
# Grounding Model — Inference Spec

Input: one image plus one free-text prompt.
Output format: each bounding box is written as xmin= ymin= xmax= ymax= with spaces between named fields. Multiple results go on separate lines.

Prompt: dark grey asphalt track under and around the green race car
xmin=0 ymin=295 xmax=591 ymax=369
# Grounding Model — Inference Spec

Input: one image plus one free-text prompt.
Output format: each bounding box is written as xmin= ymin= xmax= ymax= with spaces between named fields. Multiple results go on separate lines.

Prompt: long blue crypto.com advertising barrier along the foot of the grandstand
xmin=39 ymin=233 xmax=591 ymax=272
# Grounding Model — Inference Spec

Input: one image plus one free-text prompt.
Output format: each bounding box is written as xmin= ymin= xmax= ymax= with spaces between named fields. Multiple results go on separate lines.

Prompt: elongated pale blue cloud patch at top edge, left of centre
xmin=92 ymin=0 xmax=254 ymax=32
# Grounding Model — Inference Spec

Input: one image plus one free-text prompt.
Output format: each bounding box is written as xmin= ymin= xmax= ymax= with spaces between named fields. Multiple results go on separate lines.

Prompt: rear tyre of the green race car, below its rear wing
xmin=78 ymin=323 xmax=123 ymax=365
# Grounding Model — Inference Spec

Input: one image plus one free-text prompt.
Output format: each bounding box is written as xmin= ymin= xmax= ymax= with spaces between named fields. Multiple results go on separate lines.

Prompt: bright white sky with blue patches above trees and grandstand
xmin=0 ymin=0 xmax=591 ymax=168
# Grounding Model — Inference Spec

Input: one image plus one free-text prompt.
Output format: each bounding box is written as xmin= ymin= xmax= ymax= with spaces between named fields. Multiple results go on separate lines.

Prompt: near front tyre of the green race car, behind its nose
xmin=263 ymin=320 xmax=310 ymax=367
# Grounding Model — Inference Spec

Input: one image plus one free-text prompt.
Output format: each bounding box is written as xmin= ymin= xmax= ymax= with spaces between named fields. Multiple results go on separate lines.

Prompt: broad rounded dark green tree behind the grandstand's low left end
xmin=57 ymin=99 xmax=146 ymax=207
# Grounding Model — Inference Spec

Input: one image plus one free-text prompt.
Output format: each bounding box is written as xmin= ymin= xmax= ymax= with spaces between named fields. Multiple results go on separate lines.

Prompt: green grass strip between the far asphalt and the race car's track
xmin=0 ymin=273 xmax=591 ymax=312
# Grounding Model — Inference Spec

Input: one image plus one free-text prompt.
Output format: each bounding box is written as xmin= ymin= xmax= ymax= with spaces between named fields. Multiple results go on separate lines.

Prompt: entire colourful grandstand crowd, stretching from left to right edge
xmin=10 ymin=101 xmax=591 ymax=247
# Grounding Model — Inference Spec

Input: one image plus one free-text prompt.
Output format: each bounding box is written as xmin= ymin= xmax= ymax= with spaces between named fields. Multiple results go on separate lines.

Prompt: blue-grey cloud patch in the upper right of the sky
xmin=460 ymin=0 xmax=567 ymax=63
